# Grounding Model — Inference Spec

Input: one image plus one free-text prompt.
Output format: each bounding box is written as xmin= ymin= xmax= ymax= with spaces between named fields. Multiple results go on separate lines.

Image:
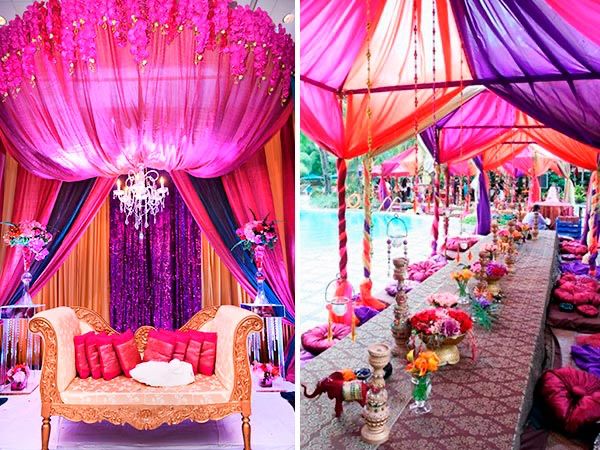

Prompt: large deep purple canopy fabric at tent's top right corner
xmin=450 ymin=0 xmax=600 ymax=147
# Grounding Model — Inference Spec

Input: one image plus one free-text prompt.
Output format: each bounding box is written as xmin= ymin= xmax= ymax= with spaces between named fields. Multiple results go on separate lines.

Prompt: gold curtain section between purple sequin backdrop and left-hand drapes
xmin=36 ymin=198 xmax=110 ymax=321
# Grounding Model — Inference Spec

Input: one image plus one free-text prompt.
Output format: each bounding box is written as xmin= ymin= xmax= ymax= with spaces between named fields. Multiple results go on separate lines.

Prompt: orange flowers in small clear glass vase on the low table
xmin=404 ymin=350 xmax=440 ymax=414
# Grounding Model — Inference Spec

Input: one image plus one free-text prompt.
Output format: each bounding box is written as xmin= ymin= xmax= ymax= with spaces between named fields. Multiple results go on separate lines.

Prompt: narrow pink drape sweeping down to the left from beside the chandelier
xmin=31 ymin=178 xmax=115 ymax=296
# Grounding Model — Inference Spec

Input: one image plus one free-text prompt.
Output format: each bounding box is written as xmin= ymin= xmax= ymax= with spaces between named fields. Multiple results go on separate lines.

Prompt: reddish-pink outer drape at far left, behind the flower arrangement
xmin=0 ymin=166 xmax=62 ymax=305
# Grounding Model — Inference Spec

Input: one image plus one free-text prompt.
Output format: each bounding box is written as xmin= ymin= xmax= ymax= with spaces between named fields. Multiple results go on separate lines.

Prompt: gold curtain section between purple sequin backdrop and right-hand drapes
xmin=202 ymin=234 xmax=248 ymax=308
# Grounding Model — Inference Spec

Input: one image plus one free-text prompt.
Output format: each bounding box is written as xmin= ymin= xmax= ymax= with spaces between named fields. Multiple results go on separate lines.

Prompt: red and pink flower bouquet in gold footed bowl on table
xmin=409 ymin=308 xmax=473 ymax=366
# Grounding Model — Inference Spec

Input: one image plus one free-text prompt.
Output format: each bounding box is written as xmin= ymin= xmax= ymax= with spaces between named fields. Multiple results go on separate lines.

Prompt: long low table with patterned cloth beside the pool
xmin=300 ymin=231 xmax=558 ymax=450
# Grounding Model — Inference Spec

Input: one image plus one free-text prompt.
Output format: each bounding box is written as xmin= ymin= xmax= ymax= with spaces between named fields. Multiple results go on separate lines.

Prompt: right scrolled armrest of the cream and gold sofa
xmin=195 ymin=305 xmax=263 ymax=401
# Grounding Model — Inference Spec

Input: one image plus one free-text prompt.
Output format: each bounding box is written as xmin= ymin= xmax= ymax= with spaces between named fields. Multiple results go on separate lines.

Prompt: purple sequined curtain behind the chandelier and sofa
xmin=110 ymin=174 xmax=202 ymax=331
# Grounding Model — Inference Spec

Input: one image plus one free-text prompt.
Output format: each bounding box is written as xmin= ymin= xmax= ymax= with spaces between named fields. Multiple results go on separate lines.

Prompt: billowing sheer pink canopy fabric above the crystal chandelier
xmin=0 ymin=28 xmax=292 ymax=181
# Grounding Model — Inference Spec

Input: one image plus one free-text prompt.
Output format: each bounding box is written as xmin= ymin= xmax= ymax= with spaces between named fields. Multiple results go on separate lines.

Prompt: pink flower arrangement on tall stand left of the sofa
xmin=3 ymin=220 xmax=52 ymax=265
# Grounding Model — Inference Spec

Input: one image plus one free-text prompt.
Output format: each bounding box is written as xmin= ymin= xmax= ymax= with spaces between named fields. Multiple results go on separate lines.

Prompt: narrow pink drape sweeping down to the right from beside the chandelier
xmin=171 ymin=171 xmax=256 ymax=296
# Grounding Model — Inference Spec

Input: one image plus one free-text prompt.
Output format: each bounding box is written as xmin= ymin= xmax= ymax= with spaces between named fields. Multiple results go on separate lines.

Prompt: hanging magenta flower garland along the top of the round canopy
xmin=0 ymin=0 xmax=294 ymax=101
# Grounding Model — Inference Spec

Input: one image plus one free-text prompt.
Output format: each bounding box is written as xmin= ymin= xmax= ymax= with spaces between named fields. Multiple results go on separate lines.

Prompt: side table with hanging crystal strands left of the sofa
xmin=0 ymin=304 xmax=45 ymax=394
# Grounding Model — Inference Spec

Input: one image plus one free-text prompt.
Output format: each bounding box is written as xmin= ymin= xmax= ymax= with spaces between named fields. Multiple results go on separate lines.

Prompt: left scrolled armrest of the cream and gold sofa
xmin=29 ymin=306 xmax=81 ymax=403
